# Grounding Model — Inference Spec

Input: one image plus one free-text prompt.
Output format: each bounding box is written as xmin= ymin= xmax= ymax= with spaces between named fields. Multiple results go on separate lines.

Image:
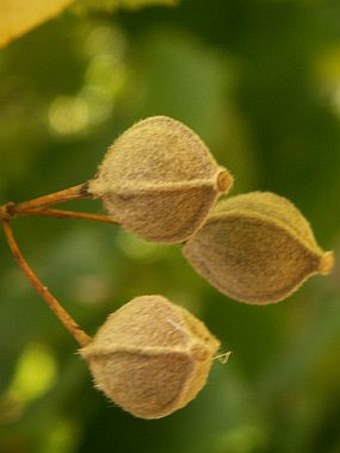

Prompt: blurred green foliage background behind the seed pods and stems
xmin=0 ymin=0 xmax=340 ymax=453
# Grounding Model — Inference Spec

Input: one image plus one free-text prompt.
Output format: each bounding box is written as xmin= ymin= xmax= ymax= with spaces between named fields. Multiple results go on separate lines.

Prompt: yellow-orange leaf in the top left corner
xmin=0 ymin=0 xmax=73 ymax=47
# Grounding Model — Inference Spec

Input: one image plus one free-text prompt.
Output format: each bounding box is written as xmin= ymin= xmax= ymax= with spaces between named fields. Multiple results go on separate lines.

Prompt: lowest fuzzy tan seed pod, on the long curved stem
xmin=80 ymin=295 xmax=220 ymax=419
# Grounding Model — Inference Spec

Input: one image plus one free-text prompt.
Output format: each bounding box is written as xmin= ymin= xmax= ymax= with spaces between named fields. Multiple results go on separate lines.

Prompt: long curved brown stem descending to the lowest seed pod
xmin=1 ymin=218 xmax=91 ymax=347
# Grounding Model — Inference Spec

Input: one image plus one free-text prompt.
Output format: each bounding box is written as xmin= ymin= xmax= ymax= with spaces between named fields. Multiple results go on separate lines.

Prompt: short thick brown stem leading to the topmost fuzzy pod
xmin=7 ymin=183 xmax=91 ymax=216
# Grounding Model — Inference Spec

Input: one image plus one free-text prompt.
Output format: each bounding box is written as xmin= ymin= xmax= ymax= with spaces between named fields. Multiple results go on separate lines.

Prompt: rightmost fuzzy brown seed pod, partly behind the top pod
xmin=183 ymin=192 xmax=334 ymax=304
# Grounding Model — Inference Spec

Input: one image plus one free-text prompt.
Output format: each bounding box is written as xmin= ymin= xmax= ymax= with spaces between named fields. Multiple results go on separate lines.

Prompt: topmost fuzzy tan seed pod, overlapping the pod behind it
xmin=88 ymin=116 xmax=233 ymax=243
